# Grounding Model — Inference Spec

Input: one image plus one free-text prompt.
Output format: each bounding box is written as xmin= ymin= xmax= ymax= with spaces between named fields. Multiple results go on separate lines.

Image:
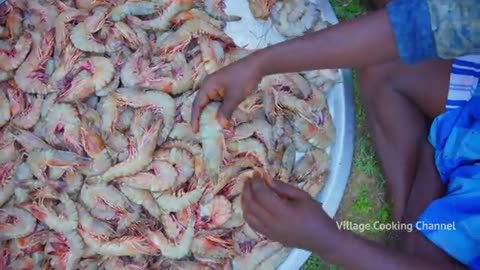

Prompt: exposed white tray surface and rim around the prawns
xmin=225 ymin=0 xmax=354 ymax=270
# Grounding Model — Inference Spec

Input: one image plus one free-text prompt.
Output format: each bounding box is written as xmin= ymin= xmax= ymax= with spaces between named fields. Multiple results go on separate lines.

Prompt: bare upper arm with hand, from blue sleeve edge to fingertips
xmin=192 ymin=10 xmax=398 ymax=131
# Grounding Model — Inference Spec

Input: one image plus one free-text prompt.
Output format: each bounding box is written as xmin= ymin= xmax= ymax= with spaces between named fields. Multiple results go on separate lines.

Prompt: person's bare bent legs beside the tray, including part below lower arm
xmin=358 ymin=60 xmax=458 ymax=261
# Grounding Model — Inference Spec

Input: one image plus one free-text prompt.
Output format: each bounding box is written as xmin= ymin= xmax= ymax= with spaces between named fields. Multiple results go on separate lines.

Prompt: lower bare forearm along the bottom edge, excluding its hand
xmin=313 ymin=231 xmax=465 ymax=270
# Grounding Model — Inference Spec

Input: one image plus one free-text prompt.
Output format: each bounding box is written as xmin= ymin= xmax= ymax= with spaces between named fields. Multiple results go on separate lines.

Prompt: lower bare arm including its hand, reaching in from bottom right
xmin=242 ymin=175 xmax=465 ymax=270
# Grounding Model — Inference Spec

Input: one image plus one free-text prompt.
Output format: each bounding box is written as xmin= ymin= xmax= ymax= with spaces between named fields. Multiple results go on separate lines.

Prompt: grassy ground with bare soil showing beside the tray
xmin=302 ymin=0 xmax=390 ymax=270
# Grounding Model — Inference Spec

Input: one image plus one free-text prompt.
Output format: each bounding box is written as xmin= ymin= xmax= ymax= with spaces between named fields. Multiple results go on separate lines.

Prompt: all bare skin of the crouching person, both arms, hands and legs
xmin=192 ymin=1 xmax=464 ymax=269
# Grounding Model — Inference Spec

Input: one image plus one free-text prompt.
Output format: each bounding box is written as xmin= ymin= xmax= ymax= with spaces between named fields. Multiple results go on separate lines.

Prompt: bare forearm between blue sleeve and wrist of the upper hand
xmin=251 ymin=10 xmax=398 ymax=75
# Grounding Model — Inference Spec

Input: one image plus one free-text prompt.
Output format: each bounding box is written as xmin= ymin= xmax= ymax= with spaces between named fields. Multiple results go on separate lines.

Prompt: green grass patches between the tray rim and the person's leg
xmin=302 ymin=0 xmax=391 ymax=270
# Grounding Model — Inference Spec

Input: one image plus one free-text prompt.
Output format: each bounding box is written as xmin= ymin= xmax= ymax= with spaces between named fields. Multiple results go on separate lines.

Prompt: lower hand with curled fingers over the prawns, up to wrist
xmin=242 ymin=175 xmax=340 ymax=255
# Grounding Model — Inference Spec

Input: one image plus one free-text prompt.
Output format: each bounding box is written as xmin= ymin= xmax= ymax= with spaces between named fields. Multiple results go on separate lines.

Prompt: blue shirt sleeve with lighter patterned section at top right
xmin=387 ymin=0 xmax=480 ymax=64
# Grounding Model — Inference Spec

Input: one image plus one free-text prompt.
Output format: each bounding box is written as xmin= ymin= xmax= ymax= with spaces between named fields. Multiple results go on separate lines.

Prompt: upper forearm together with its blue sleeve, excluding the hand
xmin=249 ymin=0 xmax=480 ymax=75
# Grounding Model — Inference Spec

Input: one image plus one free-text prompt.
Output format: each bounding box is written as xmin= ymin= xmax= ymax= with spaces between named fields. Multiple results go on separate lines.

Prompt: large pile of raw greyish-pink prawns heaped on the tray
xmin=0 ymin=0 xmax=336 ymax=269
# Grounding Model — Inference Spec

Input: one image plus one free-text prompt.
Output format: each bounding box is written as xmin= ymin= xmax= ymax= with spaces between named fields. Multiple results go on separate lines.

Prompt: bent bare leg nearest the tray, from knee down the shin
xmin=358 ymin=60 xmax=451 ymax=221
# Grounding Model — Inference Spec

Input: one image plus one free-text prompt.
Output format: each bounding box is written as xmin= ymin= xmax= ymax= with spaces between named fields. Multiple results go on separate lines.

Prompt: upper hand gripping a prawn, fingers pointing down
xmin=192 ymin=55 xmax=262 ymax=132
